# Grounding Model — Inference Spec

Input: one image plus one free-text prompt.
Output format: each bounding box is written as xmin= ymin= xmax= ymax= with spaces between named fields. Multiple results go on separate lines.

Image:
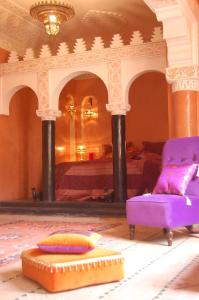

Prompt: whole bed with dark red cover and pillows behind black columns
xmin=55 ymin=144 xmax=161 ymax=201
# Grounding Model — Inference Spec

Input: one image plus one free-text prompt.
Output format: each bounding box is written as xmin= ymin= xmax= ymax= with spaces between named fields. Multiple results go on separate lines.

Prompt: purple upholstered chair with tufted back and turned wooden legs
xmin=126 ymin=136 xmax=199 ymax=246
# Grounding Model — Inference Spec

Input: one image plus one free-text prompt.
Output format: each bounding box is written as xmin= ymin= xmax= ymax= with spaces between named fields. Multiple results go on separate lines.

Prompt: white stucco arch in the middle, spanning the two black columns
xmin=49 ymin=66 xmax=108 ymax=110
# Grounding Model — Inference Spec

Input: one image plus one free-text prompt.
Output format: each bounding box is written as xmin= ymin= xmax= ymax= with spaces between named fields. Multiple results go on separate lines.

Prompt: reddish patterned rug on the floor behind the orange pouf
xmin=0 ymin=220 xmax=120 ymax=267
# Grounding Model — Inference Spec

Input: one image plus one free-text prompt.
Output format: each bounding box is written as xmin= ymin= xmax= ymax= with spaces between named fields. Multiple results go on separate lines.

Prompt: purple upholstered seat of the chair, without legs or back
xmin=126 ymin=194 xmax=199 ymax=228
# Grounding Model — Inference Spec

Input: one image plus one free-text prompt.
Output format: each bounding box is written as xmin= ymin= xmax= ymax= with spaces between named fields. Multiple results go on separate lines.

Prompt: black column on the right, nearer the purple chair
xmin=112 ymin=115 xmax=127 ymax=202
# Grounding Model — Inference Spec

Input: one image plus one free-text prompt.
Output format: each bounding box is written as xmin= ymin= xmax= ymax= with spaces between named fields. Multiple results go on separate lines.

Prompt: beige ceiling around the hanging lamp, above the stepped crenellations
xmin=0 ymin=0 xmax=161 ymax=55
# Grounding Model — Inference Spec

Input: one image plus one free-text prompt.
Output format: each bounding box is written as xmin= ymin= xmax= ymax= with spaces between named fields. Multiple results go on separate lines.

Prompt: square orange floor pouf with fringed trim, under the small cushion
xmin=21 ymin=248 xmax=124 ymax=292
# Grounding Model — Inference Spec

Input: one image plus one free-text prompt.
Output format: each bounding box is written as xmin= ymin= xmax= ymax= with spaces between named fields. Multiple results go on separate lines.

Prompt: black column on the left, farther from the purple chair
xmin=42 ymin=121 xmax=55 ymax=202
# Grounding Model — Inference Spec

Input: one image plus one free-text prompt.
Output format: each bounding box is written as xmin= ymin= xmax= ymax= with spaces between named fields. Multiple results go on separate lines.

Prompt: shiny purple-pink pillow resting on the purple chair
xmin=153 ymin=164 xmax=197 ymax=195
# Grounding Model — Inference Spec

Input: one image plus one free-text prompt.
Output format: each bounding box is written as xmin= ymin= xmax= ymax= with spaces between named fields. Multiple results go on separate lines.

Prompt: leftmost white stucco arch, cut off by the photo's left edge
xmin=0 ymin=73 xmax=39 ymax=115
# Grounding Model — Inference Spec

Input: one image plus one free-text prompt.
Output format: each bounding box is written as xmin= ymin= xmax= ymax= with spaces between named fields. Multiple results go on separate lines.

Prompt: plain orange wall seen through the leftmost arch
xmin=0 ymin=88 xmax=41 ymax=200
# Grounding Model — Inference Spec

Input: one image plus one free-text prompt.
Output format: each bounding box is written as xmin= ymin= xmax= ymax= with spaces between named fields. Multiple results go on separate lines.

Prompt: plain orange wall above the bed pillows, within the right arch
xmin=126 ymin=72 xmax=169 ymax=146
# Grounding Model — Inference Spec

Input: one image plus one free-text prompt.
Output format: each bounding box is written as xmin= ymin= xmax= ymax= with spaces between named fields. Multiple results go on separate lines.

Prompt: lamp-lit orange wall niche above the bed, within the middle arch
xmin=56 ymin=73 xmax=111 ymax=163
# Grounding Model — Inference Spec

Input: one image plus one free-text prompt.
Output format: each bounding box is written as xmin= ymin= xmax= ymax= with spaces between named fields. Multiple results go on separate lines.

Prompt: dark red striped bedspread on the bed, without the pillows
xmin=56 ymin=159 xmax=144 ymax=201
